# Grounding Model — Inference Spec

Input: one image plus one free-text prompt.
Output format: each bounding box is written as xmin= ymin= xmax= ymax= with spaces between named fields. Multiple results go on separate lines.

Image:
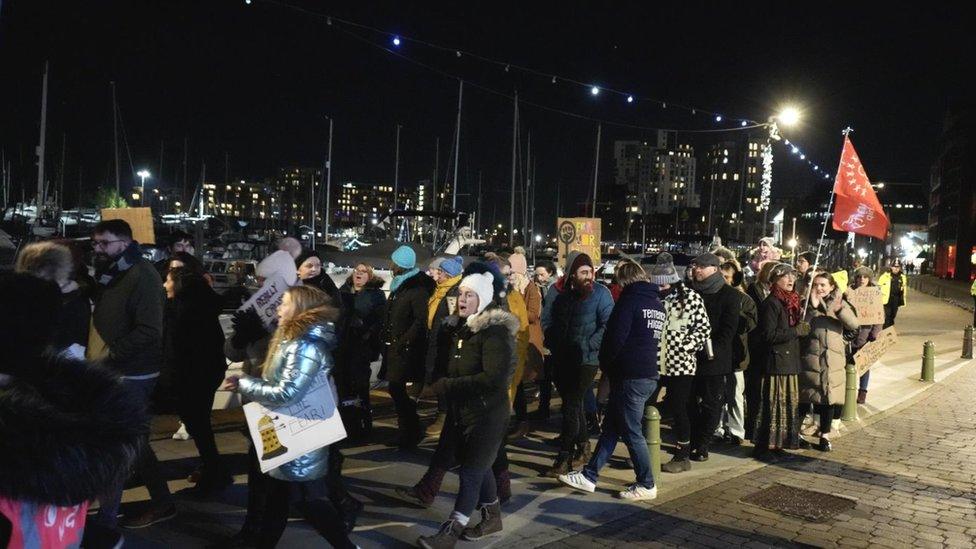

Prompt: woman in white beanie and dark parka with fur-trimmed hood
xmin=417 ymin=273 xmax=519 ymax=548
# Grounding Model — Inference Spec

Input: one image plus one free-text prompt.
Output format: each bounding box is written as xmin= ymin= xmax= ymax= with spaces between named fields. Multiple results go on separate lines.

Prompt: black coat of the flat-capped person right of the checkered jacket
xmin=696 ymin=284 xmax=742 ymax=376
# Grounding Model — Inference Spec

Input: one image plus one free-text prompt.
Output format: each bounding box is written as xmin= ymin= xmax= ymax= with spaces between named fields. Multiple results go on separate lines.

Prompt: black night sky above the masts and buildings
xmin=0 ymin=0 xmax=976 ymax=226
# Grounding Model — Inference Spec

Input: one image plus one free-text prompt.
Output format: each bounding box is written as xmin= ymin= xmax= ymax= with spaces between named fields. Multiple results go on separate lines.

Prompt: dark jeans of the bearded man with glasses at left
xmin=95 ymin=378 xmax=173 ymax=529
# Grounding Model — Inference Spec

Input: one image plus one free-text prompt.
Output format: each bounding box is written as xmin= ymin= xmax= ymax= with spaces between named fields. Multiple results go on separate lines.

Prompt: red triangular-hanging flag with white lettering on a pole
xmin=833 ymin=135 xmax=888 ymax=240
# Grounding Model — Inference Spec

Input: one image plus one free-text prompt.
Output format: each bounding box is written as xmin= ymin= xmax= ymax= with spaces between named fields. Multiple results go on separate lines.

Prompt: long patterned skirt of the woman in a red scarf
xmin=753 ymin=375 xmax=800 ymax=449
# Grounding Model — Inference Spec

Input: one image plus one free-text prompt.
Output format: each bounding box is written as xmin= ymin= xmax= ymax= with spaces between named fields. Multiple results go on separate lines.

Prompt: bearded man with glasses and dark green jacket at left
xmin=86 ymin=219 xmax=176 ymax=528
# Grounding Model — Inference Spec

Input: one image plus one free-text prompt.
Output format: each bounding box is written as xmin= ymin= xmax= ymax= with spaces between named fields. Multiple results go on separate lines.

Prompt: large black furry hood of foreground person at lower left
xmin=0 ymin=356 xmax=148 ymax=506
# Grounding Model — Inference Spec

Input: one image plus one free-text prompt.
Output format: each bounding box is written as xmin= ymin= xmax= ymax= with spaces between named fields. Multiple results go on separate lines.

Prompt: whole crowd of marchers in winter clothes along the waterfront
xmin=0 ymin=220 xmax=916 ymax=548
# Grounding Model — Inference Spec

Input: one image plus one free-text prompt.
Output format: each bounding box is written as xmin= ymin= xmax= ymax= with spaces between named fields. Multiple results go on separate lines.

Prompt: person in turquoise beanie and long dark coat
xmin=380 ymin=246 xmax=435 ymax=448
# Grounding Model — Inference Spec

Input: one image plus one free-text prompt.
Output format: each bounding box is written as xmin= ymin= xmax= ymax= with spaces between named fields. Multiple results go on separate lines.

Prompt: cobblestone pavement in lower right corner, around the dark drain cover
xmin=546 ymin=358 xmax=976 ymax=548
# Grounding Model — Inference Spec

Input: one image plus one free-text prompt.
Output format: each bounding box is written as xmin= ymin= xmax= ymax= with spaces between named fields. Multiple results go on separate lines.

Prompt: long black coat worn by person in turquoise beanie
xmin=380 ymin=272 xmax=435 ymax=383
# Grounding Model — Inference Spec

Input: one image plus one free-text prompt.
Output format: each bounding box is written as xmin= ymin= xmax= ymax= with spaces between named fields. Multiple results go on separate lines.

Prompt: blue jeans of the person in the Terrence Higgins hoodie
xmin=583 ymin=379 xmax=657 ymax=488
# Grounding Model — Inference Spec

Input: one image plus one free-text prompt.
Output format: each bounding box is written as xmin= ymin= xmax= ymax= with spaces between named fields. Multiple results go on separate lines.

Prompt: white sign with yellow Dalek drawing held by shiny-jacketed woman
xmin=244 ymin=373 xmax=346 ymax=473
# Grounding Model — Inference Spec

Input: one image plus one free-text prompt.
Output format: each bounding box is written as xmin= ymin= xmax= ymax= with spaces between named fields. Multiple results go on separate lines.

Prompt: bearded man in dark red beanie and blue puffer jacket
xmin=542 ymin=251 xmax=613 ymax=478
